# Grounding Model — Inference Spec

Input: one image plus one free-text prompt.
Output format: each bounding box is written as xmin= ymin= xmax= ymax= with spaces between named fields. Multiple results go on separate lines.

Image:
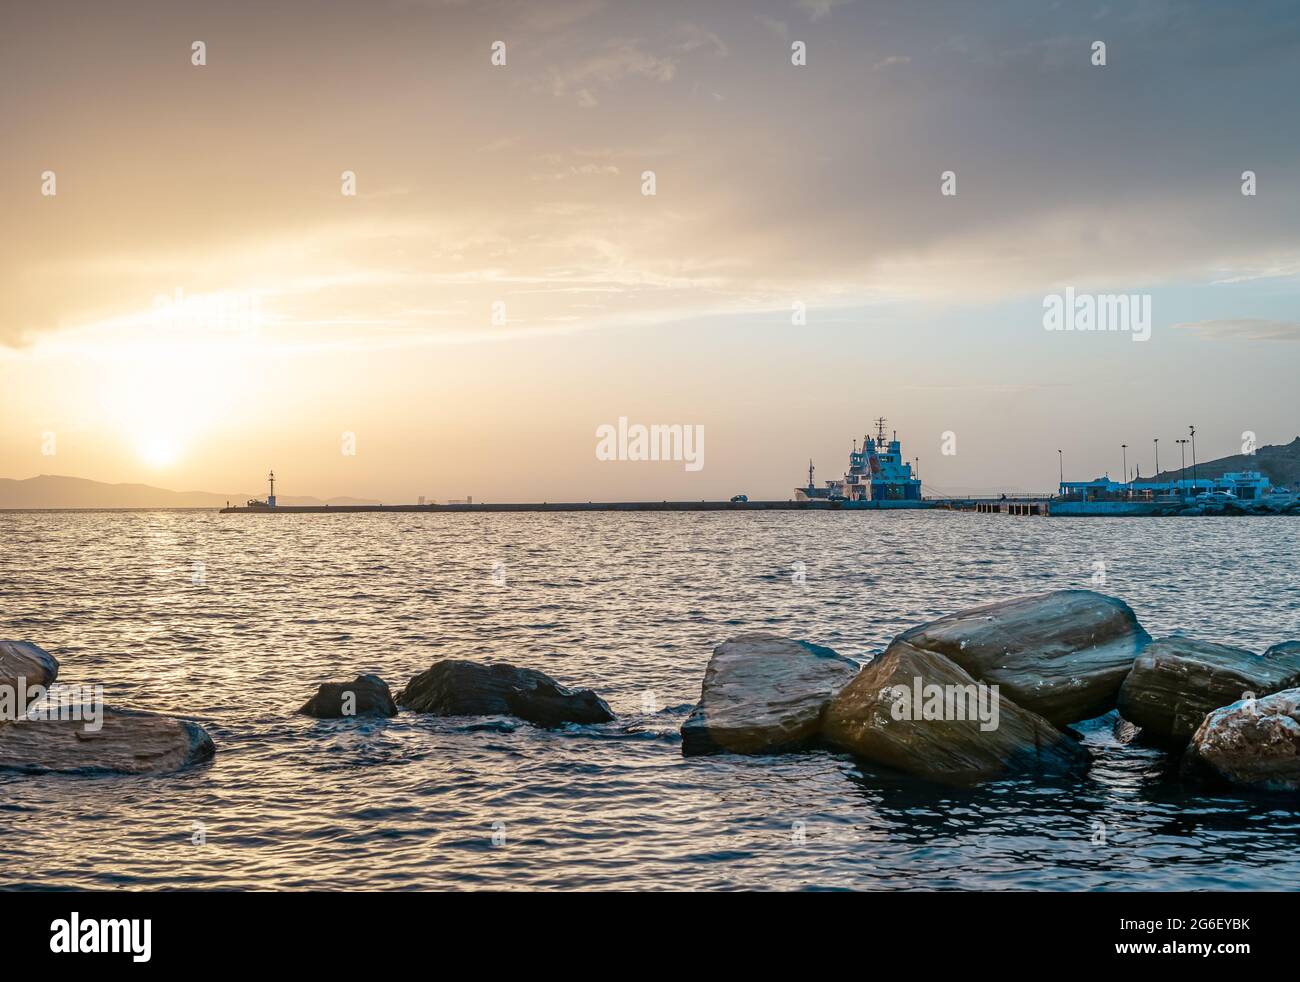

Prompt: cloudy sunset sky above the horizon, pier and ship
xmin=0 ymin=0 xmax=1300 ymax=502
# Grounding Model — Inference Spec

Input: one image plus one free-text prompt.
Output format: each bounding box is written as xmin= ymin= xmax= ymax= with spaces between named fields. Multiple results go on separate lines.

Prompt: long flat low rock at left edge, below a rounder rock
xmin=0 ymin=709 xmax=216 ymax=774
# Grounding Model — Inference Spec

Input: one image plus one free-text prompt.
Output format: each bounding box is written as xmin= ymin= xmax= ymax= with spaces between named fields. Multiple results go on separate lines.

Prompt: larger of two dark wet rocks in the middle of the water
xmin=398 ymin=658 xmax=614 ymax=727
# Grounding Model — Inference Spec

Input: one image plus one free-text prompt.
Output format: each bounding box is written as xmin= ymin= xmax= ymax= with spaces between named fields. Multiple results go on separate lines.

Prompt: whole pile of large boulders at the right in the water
xmin=683 ymin=591 xmax=1300 ymax=792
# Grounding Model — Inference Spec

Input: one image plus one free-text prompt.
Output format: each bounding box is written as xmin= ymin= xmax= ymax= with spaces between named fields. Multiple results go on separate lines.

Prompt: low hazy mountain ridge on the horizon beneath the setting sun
xmin=0 ymin=473 xmax=380 ymax=509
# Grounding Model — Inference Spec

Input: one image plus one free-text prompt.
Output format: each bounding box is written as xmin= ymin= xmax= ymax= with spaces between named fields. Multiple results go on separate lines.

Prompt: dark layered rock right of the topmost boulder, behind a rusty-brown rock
xmin=1119 ymin=637 xmax=1300 ymax=750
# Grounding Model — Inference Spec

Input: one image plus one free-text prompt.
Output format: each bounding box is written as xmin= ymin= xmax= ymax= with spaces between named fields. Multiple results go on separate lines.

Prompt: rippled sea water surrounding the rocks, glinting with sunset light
xmin=0 ymin=512 xmax=1300 ymax=890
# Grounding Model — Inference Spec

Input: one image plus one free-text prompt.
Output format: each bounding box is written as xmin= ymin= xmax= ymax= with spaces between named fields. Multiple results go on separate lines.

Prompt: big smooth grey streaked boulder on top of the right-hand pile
xmin=898 ymin=591 xmax=1151 ymax=726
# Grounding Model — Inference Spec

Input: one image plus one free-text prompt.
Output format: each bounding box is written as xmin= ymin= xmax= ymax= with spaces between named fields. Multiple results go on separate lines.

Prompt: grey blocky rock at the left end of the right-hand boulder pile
xmin=681 ymin=633 xmax=858 ymax=756
